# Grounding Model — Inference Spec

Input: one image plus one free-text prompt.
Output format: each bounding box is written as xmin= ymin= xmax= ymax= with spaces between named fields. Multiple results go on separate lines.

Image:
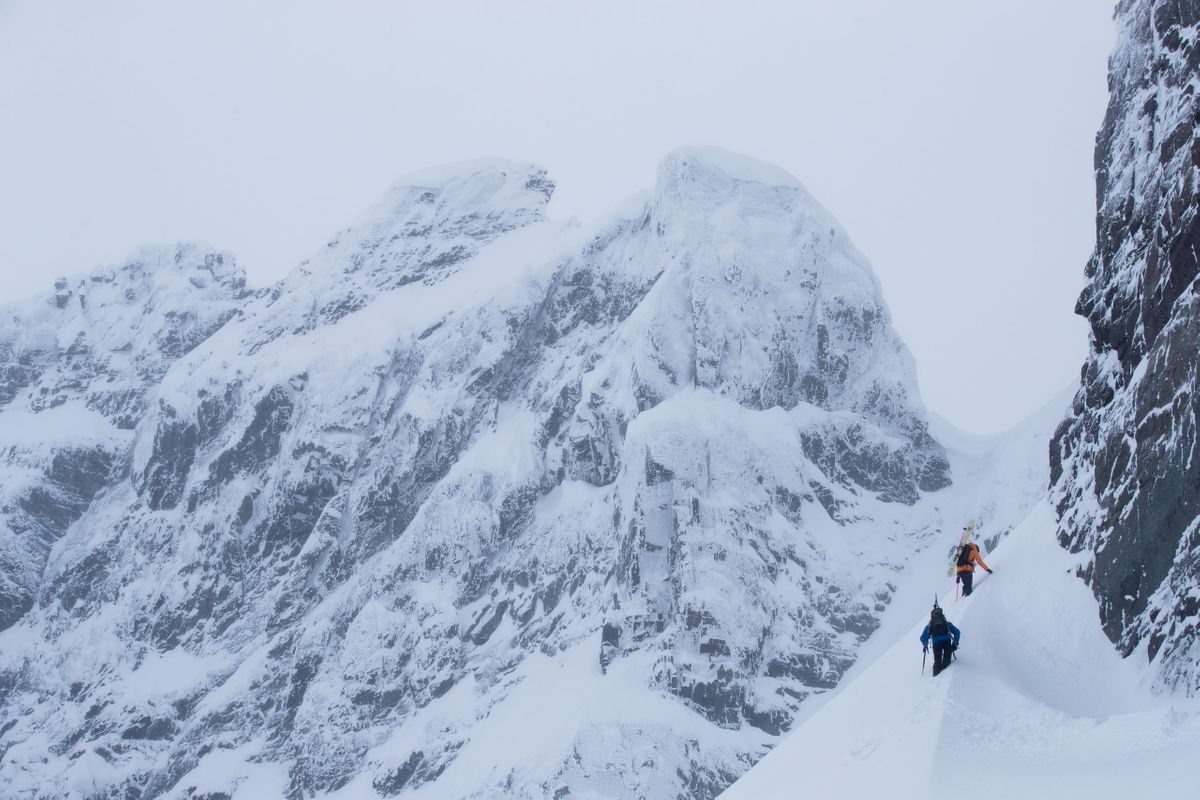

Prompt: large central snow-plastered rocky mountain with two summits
xmin=0 ymin=149 xmax=949 ymax=798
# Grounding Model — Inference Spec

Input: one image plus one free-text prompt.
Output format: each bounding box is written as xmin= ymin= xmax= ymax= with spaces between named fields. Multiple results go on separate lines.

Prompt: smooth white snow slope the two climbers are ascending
xmin=721 ymin=396 xmax=1200 ymax=800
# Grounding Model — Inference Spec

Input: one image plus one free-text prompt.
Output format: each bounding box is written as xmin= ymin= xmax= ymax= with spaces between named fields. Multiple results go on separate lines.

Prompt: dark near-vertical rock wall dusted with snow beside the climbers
xmin=1051 ymin=0 xmax=1200 ymax=691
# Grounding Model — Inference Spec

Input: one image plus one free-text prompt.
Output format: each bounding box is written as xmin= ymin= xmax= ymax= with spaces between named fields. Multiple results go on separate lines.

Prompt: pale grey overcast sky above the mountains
xmin=0 ymin=0 xmax=1114 ymax=433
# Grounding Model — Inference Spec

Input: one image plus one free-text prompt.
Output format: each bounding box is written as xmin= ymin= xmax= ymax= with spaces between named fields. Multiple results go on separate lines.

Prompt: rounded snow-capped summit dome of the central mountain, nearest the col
xmin=617 ymin=148 xmax=923 ymax=450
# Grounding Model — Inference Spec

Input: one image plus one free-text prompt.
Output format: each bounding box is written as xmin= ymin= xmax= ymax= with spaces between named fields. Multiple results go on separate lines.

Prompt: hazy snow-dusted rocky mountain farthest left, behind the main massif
xmin=0 ymin=245 xmax=250 ymax=630
